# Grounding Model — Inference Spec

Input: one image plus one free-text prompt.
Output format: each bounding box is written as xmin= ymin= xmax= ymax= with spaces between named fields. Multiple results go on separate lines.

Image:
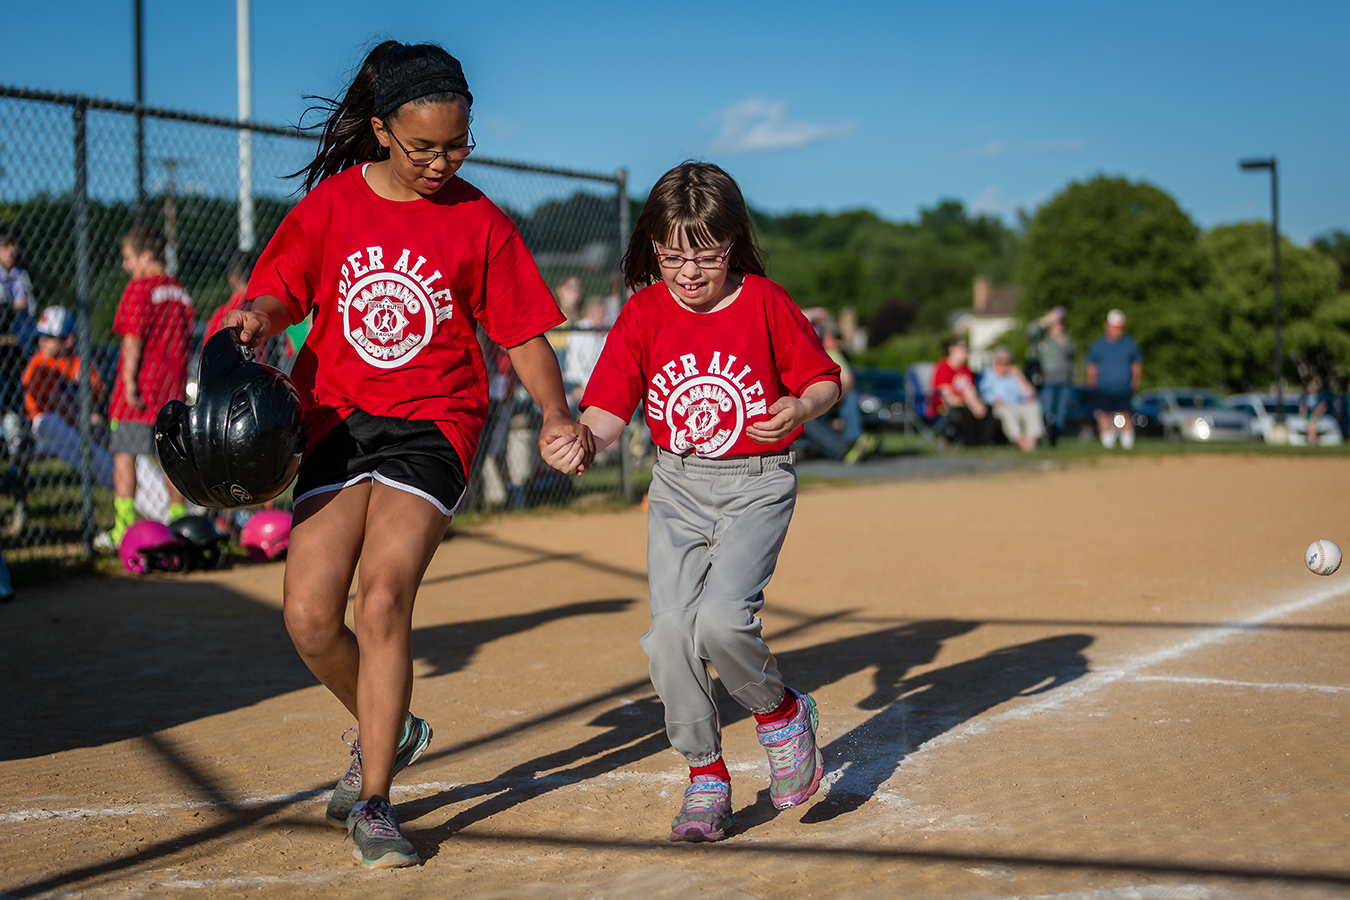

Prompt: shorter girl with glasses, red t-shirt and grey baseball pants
xmin=544 ymin=162 xmax=840 ymax=841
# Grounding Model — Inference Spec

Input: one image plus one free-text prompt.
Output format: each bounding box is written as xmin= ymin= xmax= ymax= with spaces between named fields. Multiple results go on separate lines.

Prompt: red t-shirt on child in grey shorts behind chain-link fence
xmin=108 ymin=275 xmax=192 ymax=424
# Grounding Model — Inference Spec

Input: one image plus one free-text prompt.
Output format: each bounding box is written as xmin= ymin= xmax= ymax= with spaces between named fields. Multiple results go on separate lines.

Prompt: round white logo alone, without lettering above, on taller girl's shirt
xmin=342 ymin=271 xmax=436 ymax=368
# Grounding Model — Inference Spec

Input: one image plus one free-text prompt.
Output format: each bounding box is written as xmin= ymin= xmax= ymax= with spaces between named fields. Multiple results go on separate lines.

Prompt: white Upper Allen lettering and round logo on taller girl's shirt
xmin=338 ymin=247 xmax=454 ymax=368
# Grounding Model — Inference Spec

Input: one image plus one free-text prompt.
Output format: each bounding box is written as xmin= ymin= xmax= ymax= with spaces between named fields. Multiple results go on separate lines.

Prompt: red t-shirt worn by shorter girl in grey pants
xmin=582 ymin=275 xmax=840 ymax=456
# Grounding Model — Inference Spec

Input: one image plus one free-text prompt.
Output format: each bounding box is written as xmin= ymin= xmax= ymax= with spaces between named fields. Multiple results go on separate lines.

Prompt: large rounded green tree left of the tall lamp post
xmin=1017 ymin=175 xmax=1208 ymax=367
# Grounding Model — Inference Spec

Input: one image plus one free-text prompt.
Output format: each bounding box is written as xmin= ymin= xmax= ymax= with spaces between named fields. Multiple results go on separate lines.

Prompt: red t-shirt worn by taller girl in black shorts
xmin=248 ymin=166 xmax=566 ymax=467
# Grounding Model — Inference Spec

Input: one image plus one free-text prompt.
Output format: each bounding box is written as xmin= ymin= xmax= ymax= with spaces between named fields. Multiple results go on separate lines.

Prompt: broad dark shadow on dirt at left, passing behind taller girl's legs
xmin=0 ymin=578 xmax=635 ymax=761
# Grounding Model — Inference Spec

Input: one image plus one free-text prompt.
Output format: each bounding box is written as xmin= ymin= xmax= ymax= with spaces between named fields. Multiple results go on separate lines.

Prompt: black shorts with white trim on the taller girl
xmin=294 ymin=410 xmax=466 ymax=515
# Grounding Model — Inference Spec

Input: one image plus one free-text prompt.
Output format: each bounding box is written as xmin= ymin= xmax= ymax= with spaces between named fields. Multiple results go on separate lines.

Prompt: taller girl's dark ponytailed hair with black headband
xmin=290 ymin=40 xmax=474 ymax=192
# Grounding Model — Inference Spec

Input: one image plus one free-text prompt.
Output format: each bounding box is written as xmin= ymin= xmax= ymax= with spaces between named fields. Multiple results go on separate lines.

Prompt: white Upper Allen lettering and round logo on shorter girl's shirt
xmin=647 ymin=352 xmax=768 ymax=456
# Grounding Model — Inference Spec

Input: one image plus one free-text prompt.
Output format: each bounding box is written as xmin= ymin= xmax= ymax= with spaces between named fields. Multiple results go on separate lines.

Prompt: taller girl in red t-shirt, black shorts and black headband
xmin=224 ymin=40 xmax=591 ymax=868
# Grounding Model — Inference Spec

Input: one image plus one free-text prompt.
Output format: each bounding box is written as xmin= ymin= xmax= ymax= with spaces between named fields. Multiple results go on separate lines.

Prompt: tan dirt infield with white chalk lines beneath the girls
xmin=0 ymin=456 xmax=1350 ymax=900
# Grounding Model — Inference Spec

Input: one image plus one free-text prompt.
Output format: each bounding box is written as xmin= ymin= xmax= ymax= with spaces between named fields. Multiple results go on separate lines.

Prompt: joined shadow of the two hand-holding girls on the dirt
xmin=400 ymin=619 xmax=1092 ymax=854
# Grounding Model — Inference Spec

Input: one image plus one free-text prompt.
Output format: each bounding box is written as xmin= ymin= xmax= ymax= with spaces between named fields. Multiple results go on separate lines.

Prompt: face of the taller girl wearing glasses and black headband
xmin=367 ymin=103 xmax=470 ymax=200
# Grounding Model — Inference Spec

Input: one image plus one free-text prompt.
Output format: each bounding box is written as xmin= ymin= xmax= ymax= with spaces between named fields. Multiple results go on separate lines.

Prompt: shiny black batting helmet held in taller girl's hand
xmin=155 ymin=327 xmax=305 ymax=509
